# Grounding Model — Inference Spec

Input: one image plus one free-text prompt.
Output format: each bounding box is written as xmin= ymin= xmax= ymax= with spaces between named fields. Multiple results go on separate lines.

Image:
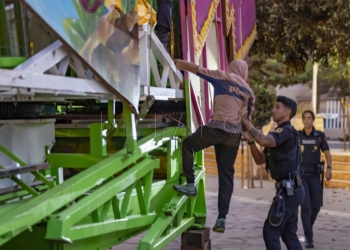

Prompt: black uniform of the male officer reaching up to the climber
xmin=263 ymin=121 xmax=305 ymax=250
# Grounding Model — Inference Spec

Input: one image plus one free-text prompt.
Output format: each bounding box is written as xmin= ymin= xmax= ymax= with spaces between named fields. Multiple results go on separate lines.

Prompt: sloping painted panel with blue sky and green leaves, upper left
xmin=21 ymin=0 xmax=140 ymax=112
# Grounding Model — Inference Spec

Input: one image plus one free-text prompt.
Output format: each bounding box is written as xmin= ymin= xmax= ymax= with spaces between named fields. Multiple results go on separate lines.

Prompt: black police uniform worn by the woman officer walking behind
xmin=298 ymin=129 xmax=329 ymax=242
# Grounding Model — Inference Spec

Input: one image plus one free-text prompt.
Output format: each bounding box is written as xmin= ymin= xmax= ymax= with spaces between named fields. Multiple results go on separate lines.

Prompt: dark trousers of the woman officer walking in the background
xmin=300 ymin=175 xmax=322 ymax=239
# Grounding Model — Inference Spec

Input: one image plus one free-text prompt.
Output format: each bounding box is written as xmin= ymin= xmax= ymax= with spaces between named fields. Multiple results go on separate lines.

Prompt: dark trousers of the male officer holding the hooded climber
xmin=263 ymin=185 xmax=305 ymax=250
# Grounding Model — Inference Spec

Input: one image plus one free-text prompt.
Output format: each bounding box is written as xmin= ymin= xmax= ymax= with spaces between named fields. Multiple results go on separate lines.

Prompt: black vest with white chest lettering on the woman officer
xmin=298 ymin=130 xmax=321 ymax=168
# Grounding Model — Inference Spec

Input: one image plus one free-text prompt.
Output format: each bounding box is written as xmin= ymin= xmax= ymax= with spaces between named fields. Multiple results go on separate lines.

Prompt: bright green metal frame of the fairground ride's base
xmin=0 ymin=95 xmax=206 ymax=250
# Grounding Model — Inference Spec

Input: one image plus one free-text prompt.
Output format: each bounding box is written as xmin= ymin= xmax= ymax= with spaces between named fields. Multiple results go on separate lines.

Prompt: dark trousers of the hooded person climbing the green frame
xmin=182 ymin=126 xmax=241 ymax=218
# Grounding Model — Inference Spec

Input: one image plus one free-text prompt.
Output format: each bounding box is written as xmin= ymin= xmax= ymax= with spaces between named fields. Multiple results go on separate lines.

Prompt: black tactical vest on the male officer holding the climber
xmin=265 ymin=126 xmax=301 ymax=181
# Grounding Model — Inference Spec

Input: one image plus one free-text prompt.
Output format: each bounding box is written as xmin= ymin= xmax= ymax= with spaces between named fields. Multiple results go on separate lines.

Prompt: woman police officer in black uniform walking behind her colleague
xmin=298 ymin=110 xmax=332 ymax=248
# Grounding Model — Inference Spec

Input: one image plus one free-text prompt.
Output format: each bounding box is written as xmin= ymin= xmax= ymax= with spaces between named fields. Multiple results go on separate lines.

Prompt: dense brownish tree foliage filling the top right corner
xmin=251 ymin=0 xmax=350 ymax=75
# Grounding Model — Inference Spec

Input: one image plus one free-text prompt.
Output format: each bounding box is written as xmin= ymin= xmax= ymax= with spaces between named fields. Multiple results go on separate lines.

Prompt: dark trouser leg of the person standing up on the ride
xmin=156 ymin=0 xmax=172 ymax=44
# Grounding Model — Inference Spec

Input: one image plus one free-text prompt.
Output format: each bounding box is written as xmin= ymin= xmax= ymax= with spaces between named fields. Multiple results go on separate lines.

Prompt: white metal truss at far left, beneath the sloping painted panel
xmin=0 ymin=41 xmax=116 ymax=101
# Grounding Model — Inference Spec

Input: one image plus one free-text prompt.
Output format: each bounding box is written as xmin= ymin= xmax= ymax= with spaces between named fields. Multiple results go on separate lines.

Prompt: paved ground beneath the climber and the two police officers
xmin=118 ymin=175 xmax=350 ymax=250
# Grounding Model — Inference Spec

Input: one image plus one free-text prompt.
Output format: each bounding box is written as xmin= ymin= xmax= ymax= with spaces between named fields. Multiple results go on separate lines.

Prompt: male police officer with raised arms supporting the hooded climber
xmin=240 ymin=96 xmax=305 ymax=250
